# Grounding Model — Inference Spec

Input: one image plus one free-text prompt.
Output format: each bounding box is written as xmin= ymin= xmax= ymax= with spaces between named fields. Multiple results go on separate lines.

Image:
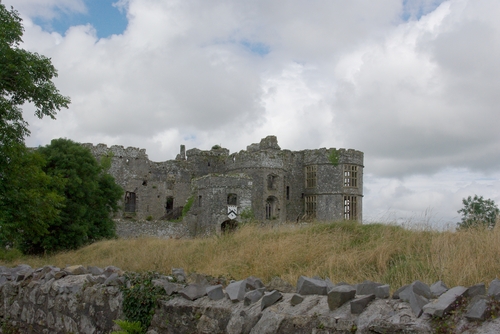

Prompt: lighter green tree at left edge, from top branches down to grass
xmin=0 ymin=4 xmax=70 ymax=250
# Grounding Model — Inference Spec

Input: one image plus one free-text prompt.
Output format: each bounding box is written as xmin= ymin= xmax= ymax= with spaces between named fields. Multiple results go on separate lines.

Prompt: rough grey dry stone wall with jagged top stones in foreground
xmin=0 ymin=265 xmax=500 ymax=334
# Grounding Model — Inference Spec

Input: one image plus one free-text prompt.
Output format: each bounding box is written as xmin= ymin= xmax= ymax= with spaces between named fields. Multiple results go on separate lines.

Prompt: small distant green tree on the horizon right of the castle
xmin=458 ymin=195 xmax=500 ymax=228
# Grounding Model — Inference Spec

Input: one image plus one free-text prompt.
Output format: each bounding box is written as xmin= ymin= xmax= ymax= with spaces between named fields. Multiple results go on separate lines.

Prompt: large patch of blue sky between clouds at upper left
xmin=33 ymin=0 xmax=128 ymax=38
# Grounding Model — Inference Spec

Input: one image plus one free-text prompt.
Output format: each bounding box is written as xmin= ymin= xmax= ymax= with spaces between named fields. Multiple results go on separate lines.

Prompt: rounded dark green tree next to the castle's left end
xmin=30 ymin=139 xmax=123 ymax=253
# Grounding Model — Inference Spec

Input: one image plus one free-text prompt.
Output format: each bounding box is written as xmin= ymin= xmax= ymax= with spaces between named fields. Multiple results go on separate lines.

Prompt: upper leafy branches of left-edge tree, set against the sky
xmin=0 ymin=4 xmax=70 ymax=149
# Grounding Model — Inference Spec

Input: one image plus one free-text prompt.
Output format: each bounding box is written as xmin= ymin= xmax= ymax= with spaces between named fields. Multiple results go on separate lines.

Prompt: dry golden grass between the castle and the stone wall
xmin=3 ymin=222 xmax=500 ymax=288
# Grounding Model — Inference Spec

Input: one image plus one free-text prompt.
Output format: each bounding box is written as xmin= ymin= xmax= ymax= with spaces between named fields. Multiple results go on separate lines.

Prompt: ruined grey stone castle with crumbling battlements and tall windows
xmin=84 ymin=136 xmax=363 ymax=235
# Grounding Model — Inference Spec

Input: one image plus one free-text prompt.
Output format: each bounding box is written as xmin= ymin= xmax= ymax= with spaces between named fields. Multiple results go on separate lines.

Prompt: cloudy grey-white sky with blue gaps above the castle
xmin=2 ymin=0 xmax=500 ymax=226
